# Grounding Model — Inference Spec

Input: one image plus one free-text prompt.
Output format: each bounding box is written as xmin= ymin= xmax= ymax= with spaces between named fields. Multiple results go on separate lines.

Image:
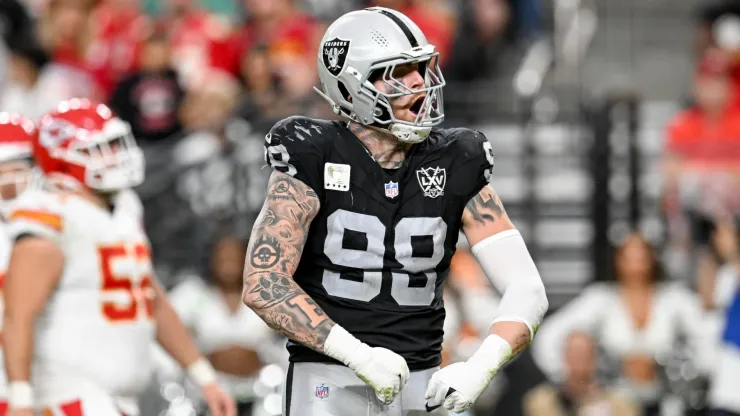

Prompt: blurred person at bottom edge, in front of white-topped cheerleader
xmin=524 ymin=331 xmax=642 ymax=416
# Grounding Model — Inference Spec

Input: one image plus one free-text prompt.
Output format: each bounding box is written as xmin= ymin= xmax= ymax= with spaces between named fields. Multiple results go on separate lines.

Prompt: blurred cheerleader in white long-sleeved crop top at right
xmin=533 ymin=233 xmax=709 ymax=415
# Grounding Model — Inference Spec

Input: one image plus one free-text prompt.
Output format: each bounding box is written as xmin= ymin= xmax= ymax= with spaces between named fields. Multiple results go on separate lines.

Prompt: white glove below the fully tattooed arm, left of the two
xmin=324 ymin=325 xmax=409 ymax=404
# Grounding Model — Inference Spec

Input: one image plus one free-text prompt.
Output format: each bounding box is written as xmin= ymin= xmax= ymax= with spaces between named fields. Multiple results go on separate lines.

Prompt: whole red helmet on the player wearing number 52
xmin=33 ymin=98 xmax=144 ymax=193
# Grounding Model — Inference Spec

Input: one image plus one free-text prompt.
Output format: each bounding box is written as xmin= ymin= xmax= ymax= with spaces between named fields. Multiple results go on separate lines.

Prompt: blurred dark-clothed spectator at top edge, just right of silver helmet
xmin=445 ymin=0 xmax=509 ymax=82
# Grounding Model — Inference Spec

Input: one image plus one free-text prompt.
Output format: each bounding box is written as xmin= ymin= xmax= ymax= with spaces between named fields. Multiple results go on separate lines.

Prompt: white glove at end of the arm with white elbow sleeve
xmin=425 ymin=335 xmax=513 ymax=413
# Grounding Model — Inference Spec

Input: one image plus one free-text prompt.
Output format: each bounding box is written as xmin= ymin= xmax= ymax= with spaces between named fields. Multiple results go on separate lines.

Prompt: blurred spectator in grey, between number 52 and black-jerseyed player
xmin=138 ymin=70 xmax=258 ymax=277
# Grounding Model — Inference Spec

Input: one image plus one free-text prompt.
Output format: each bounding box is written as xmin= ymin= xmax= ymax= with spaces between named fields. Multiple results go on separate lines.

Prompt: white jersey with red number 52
xmin=9 ymin=190 xmax=155 ymax=404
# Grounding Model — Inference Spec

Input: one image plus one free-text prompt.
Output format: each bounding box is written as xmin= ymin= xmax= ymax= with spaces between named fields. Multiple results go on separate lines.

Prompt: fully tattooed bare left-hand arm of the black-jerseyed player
xmin=242 ymin=172 xmax=334 ymax=352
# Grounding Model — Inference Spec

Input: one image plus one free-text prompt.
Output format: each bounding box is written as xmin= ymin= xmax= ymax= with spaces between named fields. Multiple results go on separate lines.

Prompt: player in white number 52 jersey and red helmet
xmin=4 ymin=99 xmax=235 ymax=416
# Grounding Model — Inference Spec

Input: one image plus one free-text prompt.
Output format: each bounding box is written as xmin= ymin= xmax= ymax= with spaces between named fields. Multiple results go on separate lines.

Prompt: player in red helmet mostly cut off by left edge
xmin=0 ymin=113 xmax=36 ymax=416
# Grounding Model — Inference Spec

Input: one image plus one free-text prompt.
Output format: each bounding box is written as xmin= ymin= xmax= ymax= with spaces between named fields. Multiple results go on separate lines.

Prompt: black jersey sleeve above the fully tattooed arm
xmin=265 ymin=117 xmax=324 ymax=195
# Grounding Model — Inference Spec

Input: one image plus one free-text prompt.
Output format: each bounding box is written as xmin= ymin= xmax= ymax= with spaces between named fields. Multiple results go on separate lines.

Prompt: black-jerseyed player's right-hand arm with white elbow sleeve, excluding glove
xmin=462 ymin=185 xmax=547 ymax=354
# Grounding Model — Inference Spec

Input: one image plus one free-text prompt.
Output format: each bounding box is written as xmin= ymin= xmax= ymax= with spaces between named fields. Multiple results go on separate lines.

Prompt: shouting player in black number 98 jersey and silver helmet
xmin=243 ymin=7 xmax=548 ymax=416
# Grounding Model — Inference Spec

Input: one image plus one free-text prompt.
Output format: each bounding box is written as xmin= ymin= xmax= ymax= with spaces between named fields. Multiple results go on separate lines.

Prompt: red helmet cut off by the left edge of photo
xmin=0 ymin=112 xmax=36 ymax=202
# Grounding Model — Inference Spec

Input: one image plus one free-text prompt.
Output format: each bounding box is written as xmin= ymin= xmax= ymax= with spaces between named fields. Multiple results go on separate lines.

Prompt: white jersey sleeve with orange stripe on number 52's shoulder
xmin=8 ymin=190 xmax=64 ymax=243
